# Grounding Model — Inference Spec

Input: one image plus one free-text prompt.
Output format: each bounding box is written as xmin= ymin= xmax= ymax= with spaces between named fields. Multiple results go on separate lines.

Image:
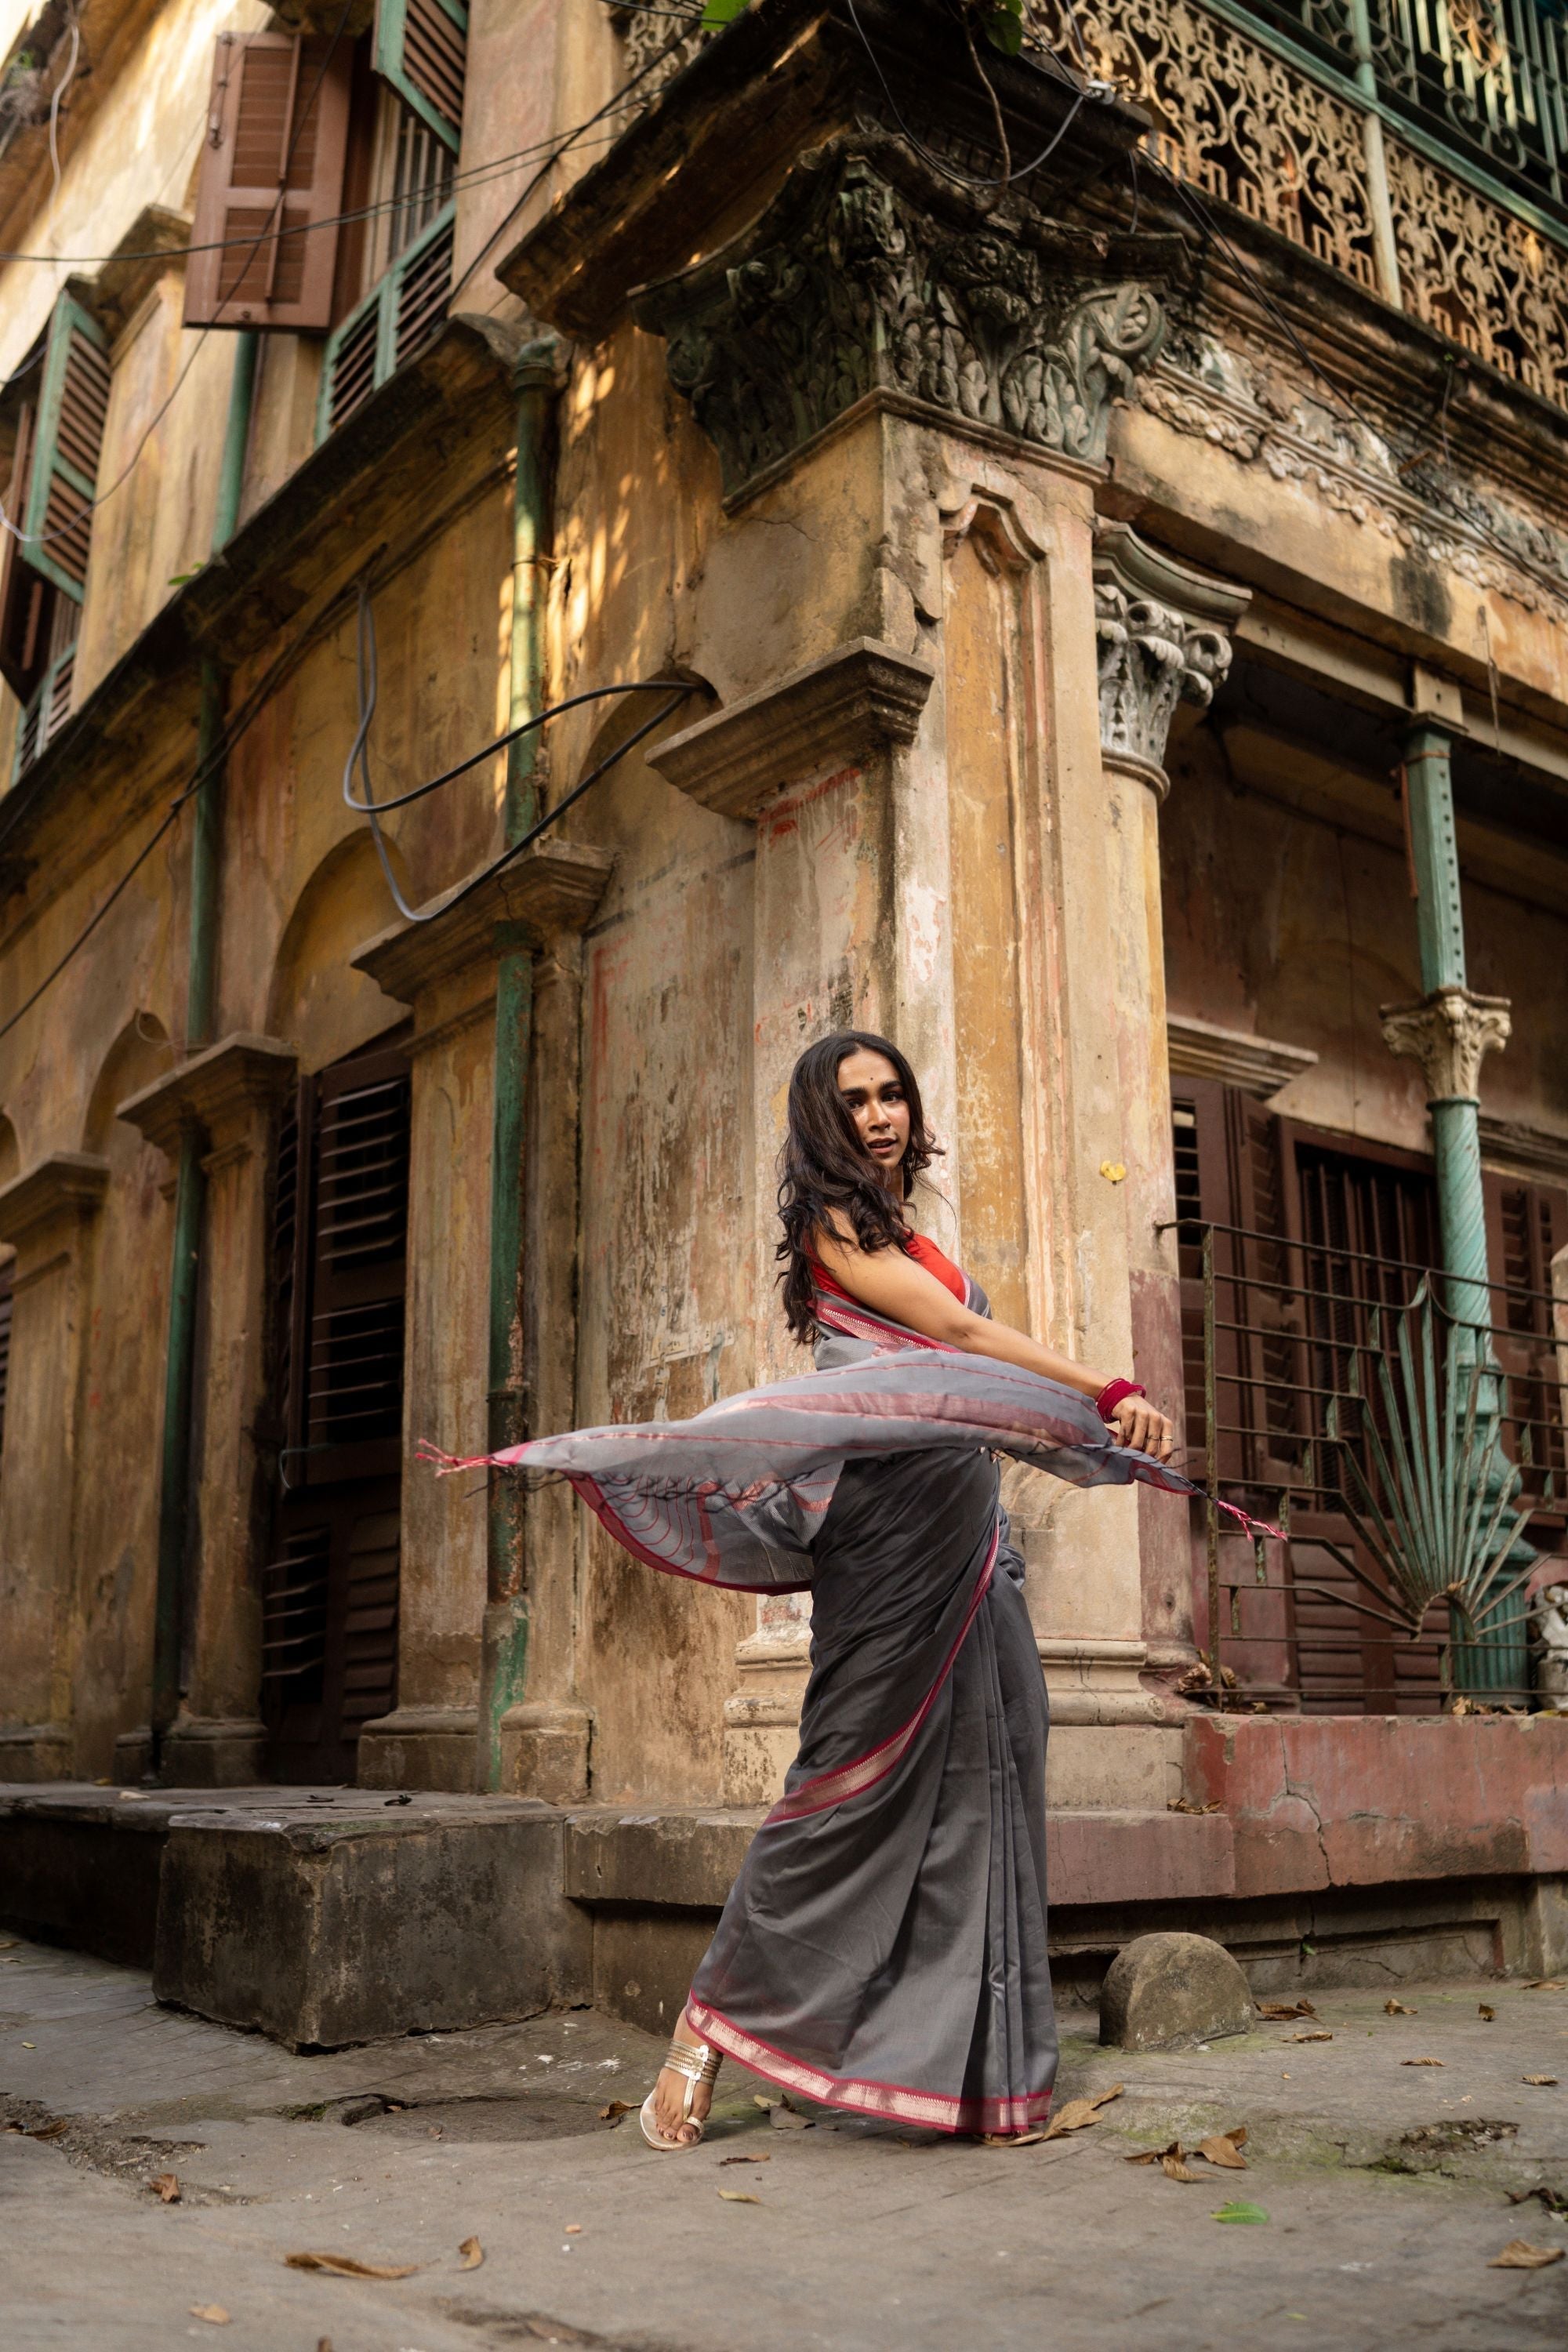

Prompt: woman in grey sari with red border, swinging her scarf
xmin=439 ymin=1030 xmax=1222 ymax=2150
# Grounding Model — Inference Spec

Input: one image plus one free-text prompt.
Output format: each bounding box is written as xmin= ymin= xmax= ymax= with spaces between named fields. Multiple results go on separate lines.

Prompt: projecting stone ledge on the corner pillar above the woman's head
xmin=647 ymin=637 xmax=935 ymax=816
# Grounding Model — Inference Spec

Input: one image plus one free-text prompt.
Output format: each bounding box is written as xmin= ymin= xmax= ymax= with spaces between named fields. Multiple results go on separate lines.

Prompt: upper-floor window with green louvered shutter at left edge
xmin=0 ymin=294 xmax=111 ymax=781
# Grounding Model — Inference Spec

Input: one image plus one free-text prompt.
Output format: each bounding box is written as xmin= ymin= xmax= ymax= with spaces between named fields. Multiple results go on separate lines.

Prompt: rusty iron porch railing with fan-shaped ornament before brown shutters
xmin=1178 ymin=1223 xmax=1568 ymax=1715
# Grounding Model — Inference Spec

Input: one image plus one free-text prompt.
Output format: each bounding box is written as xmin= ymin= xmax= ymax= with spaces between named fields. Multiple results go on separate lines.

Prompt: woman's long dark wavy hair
xmin=774 ymin=1030 xmax=940 ymax=1345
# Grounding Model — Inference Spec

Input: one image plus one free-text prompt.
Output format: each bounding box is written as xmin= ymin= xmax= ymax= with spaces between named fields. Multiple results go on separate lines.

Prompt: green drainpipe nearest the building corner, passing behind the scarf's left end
xmin=480 ymin=336 xmax=557 ymax=1788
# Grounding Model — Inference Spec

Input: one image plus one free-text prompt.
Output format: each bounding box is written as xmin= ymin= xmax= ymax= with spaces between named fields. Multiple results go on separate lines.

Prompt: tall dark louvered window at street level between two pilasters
xmin=261 ymin=1047 xmax=409 ymax=1780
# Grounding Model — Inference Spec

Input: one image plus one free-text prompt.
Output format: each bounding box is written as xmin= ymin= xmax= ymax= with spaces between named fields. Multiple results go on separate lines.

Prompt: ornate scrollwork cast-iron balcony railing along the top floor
xmin=621 ymin=0 xmax=1568 ymax=407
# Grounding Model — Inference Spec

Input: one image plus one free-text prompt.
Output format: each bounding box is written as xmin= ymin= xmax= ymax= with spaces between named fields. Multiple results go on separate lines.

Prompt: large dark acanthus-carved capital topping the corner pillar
xmin=633 ymin=132 xmax=1185 ymax=496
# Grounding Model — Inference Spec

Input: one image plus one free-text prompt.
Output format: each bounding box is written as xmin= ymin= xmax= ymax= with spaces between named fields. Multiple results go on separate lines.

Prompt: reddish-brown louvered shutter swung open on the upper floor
xmin=186 ymin=33 xmax=353 ymax=332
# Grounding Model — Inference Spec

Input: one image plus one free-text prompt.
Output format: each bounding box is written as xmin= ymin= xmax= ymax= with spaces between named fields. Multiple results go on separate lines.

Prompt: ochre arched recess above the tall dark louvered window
xmin=268 ymin=833 xmax=414 ymax=1077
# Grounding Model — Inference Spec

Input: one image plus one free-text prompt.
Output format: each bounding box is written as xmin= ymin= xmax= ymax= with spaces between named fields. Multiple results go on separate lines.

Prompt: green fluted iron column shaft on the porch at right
xmin=1406 ymin=722 xmax=1535 ymax=1696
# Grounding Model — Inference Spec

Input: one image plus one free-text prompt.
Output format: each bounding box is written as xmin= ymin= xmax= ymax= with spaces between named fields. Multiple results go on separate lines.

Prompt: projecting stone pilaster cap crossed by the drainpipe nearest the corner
xmin=350 ymin=842 xmax=614 ymax=1004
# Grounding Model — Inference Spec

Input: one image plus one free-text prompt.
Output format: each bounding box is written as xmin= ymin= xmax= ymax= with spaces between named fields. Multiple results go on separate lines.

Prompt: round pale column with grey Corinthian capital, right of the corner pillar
xmin=1086 ymin=522 xmax=1250 ymax=1722
